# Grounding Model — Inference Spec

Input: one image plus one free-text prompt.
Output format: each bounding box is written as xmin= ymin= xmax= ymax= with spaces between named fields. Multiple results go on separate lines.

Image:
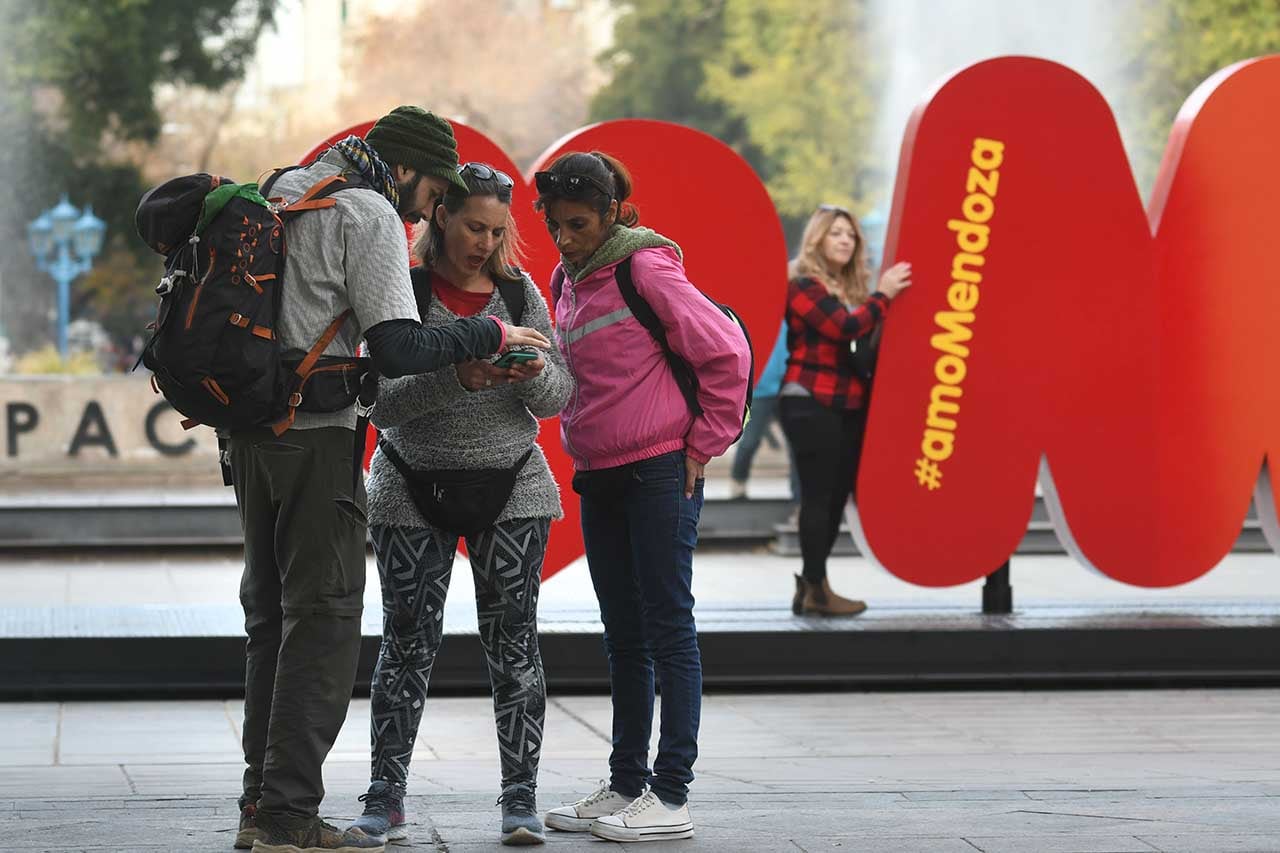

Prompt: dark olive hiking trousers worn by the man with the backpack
xmin=230 ymin=427 xmax=366 ymax=820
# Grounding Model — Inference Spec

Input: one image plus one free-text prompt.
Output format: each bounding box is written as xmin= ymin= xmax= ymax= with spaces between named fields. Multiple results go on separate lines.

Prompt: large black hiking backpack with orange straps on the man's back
xmin=133 ymin=167 xmax=376 ymax=475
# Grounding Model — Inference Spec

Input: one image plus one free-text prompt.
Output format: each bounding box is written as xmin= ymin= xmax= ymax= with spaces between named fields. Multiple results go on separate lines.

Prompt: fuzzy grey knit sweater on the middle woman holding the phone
xmin=367 ymin=272 xmax=573 ymax=528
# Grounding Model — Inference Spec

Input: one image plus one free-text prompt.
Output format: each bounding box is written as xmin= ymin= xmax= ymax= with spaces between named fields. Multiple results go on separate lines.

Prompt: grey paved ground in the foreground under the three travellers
xmin=0 ymin=686 xmax=1280 ymax=853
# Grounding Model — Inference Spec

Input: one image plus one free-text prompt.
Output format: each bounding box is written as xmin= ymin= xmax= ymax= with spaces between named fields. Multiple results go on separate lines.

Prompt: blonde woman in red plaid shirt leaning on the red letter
xmin=780 ymin=205 xmax=911 ymax=616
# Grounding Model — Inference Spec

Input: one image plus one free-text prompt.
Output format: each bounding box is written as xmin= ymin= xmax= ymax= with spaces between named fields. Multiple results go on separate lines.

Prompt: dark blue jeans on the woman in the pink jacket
xmin=573 ymin=451 xmax=703 ymax=806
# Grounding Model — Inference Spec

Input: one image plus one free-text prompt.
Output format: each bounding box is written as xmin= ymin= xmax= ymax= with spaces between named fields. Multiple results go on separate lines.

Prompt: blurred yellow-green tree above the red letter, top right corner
xmin=1119 ymin=0 xmax=1280 ymax=191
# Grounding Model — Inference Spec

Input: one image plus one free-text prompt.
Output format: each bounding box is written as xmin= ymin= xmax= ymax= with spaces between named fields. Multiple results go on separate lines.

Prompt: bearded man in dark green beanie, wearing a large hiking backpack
xmin=138 ymin=106 xmax=549 ymax=853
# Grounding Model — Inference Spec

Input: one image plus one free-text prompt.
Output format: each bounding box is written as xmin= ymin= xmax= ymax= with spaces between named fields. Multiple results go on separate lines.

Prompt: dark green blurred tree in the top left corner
xmin=0 ymin=0 xmax=276 ymax=350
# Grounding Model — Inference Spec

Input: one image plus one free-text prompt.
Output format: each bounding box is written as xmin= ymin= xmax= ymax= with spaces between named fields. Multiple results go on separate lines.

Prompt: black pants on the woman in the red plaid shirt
xmin=782 ymin=397 xmax=867 ymax=584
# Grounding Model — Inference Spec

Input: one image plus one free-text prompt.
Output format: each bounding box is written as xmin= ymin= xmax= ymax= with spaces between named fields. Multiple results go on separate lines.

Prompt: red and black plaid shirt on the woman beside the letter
xmin=782 ymin=278 xmax=888 ymax=409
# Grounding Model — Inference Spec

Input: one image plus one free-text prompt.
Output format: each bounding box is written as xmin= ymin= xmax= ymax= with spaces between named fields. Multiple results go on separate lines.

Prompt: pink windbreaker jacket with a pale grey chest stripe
xmin=552 ymin=246 xmax=750 ymax=470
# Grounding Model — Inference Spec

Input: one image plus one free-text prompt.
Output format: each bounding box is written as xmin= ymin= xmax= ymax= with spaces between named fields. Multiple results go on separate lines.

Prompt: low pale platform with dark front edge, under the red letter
xmin=0 ymin=549 xmax=1280 ymax=699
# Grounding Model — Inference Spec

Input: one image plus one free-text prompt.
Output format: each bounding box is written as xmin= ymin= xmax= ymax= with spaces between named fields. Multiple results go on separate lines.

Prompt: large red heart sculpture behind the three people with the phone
xmin=302 ymin=119 xmax=787 ymax=579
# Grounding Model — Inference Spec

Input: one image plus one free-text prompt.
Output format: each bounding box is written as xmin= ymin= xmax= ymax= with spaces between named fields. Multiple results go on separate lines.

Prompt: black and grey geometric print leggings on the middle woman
xmin=370 ymin=519 xmax=550 ymax=790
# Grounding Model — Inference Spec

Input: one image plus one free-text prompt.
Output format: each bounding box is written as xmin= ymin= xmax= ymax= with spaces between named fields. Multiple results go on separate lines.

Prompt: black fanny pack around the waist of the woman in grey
xmin=378 ymin=438 xmax=534 ymax=537
